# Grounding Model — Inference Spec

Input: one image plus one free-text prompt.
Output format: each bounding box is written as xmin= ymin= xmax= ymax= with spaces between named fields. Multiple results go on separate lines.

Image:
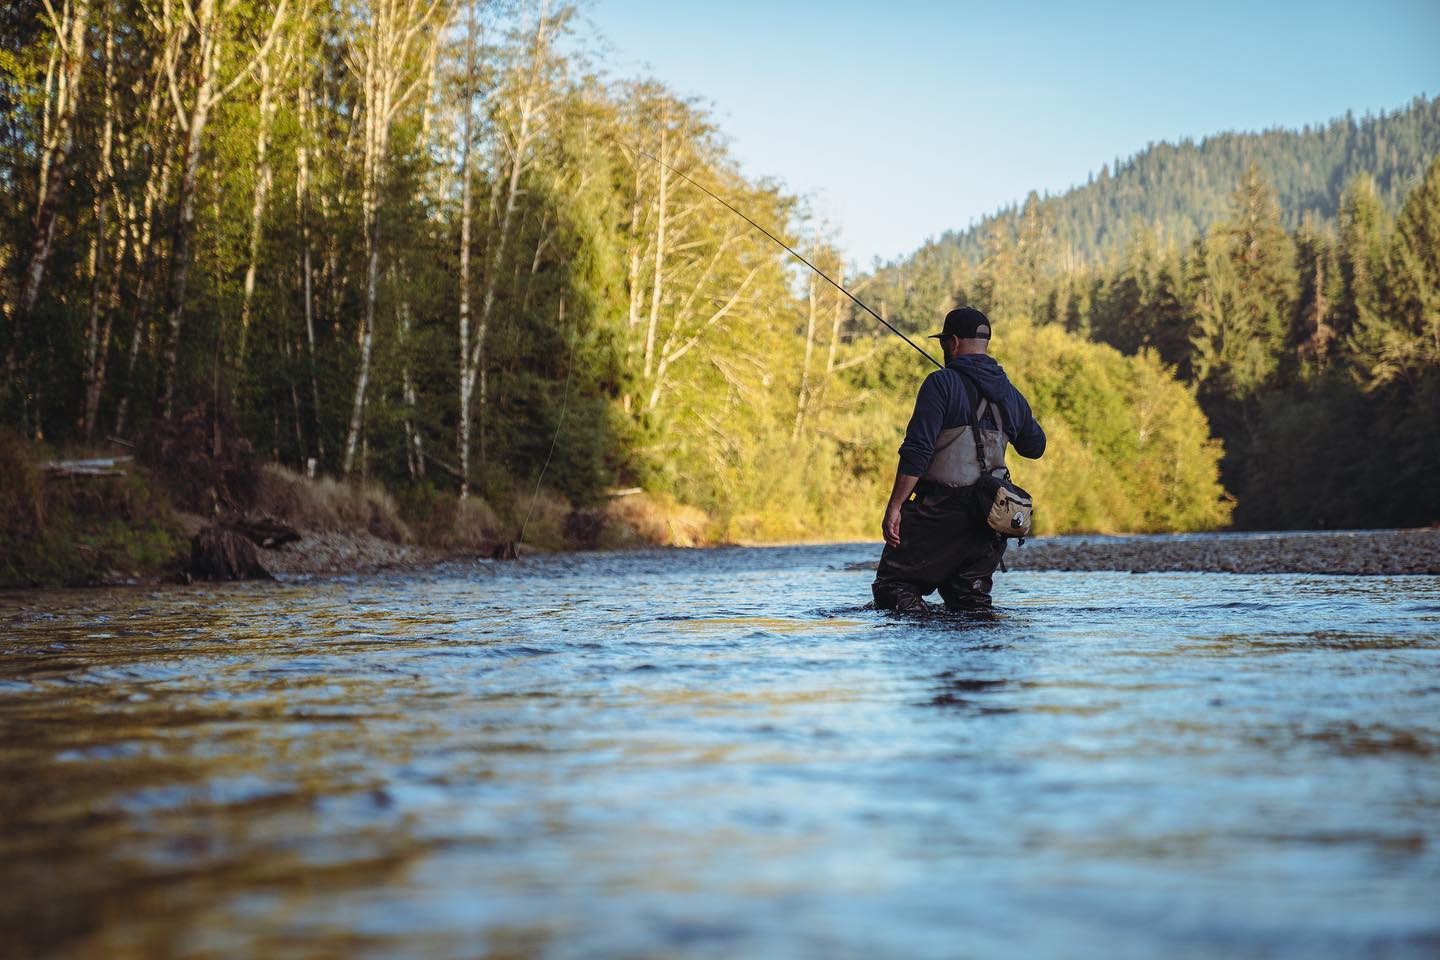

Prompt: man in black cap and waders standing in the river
xmin=871 ymin=307 xmax=1045 ymax=612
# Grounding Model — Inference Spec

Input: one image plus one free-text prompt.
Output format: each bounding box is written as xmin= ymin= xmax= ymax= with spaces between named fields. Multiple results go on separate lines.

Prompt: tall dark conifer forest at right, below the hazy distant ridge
xmin=870 ymin=151 xmax=1440 ymax=528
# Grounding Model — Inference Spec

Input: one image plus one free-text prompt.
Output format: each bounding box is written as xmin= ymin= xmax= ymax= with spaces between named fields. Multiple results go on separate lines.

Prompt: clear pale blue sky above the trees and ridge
xmin=585 ymin=0 xmax=1440 ymax=266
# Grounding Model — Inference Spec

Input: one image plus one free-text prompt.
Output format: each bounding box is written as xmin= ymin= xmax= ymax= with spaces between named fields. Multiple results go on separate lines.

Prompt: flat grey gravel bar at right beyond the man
xmin=1005 ymin=528 xmax=1440 ymax=576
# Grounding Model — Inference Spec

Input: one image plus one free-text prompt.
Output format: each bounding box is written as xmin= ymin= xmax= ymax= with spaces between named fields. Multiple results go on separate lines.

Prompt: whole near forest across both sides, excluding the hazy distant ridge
xmin=14 ymin=0 xmax=1416 ymax=578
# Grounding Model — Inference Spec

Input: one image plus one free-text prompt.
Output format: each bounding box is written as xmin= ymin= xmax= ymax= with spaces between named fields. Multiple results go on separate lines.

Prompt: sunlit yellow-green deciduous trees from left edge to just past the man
xmin=0 ymin=0 xmax=1228 ymax=555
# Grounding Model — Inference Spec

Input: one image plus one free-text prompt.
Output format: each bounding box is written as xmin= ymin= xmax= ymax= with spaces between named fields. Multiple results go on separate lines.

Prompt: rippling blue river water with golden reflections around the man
xmin=0 ymin=544 xmax=1440 ymax=959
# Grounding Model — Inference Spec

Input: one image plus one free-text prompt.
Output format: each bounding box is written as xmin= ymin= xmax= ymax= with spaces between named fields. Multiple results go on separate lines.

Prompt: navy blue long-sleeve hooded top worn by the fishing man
xmin=900 ymin=354 xmax=1045 ymax=476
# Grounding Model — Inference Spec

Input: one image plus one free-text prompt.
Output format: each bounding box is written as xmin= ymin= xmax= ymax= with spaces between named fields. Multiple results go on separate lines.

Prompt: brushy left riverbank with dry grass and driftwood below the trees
xmin=0 ymin=417 xmax=714 ymax=587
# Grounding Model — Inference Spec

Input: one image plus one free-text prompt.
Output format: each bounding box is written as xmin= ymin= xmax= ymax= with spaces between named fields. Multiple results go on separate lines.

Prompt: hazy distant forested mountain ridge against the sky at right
xmin=890 ymin=96 xmax=1440 ymax=266
